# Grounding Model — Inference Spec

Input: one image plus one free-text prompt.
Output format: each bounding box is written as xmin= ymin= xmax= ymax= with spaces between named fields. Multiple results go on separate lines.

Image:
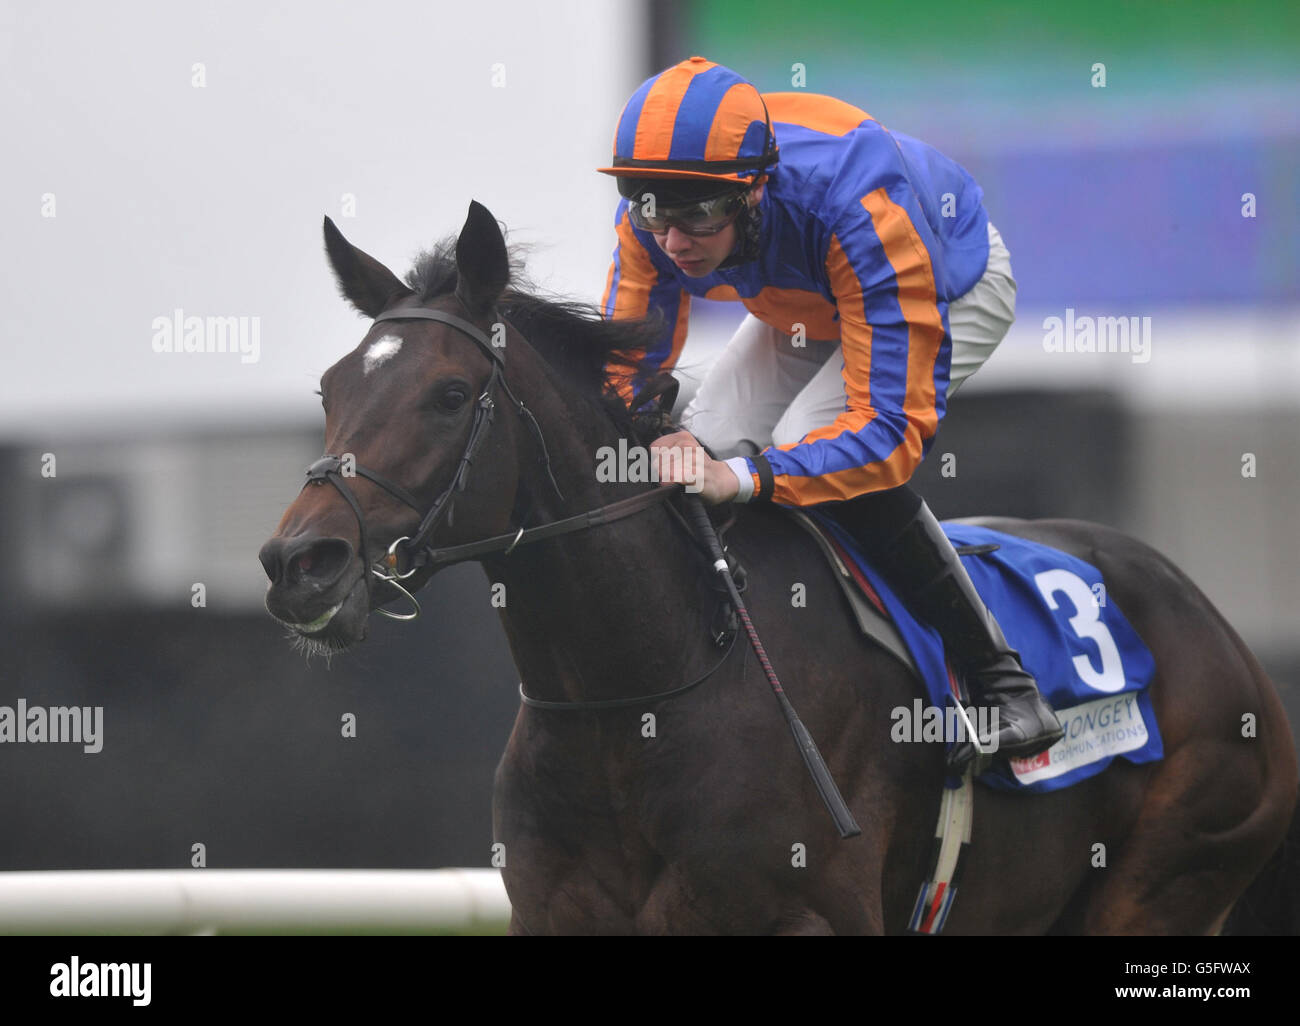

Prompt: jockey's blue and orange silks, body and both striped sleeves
xmin=603 ymin=92 xmax=988 ymax=506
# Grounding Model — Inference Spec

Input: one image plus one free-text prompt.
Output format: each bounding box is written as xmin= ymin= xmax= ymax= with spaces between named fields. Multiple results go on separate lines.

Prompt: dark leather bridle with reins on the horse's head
xmin=303 ymin=296 xmax=679 ymax=620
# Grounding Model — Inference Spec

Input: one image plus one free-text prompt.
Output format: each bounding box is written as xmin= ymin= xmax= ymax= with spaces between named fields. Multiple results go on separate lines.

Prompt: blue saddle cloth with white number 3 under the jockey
xmin=807 ymin=510 xmax=1165 ymax=793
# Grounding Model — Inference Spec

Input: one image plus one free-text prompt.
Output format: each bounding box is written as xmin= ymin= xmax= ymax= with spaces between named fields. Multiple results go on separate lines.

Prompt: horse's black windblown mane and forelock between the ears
xmin=406 ymin=237 xmax=664 ymax=437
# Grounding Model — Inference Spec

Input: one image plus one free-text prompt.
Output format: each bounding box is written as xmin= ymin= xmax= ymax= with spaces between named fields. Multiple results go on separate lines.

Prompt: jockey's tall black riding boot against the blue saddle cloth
xmin=836 ymin=489 xmax=1065 ymax=769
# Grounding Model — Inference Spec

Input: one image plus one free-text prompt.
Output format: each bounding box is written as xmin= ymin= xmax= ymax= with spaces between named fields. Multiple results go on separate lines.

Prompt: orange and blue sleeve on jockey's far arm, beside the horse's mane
xmin=601 ymin=199 xmax=690 ymax=403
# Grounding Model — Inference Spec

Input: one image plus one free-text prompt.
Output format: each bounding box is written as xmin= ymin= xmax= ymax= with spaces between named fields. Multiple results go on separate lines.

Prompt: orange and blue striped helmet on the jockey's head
xmin=597 ymin=57 xmax=777 ymax=192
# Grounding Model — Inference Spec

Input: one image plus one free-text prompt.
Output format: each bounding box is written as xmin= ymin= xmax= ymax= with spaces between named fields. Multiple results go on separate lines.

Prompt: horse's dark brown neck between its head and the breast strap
xmin=484 ymin=361 xmax=715 ymax=701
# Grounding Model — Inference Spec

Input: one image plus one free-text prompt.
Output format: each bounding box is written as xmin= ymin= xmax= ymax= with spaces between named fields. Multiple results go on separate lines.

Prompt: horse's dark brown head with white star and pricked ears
xmin=260 ymin=203 xmax=519 ymax=651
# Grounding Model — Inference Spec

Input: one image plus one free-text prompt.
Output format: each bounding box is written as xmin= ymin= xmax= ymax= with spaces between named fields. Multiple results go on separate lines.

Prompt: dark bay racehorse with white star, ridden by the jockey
xmin=261 ymin=204 xmax=1297 ymax=934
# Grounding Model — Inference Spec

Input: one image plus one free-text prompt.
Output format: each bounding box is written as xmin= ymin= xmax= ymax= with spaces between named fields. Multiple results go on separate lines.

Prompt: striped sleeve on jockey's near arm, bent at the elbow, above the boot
xmin=762 ymin=183 xmax=952 ymax=506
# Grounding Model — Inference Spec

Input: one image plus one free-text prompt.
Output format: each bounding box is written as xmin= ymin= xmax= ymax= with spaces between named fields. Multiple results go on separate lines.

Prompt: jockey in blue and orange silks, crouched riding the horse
xmin=599 ymin=57 xmax=1062 ymax=766
